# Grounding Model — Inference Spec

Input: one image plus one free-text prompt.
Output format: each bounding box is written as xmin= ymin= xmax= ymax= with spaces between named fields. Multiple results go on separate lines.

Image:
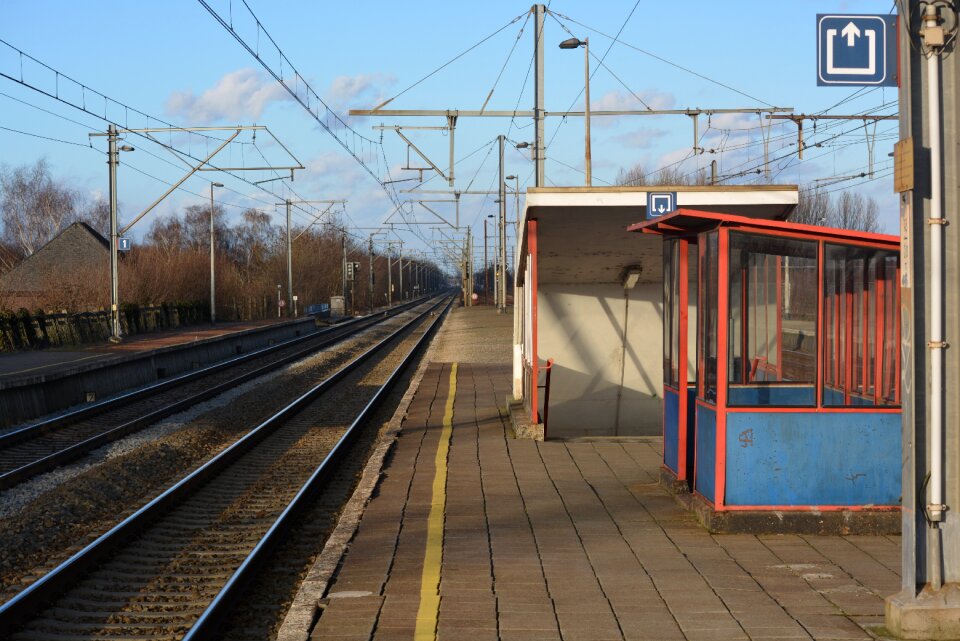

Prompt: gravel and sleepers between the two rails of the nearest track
xmin=4 ymin=302 xmax=442 ymax=641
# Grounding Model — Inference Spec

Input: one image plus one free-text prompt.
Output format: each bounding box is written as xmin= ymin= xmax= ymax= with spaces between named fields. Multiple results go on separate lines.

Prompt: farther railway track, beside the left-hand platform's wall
xmin=0 ymin=301 xmax=428 ymax=490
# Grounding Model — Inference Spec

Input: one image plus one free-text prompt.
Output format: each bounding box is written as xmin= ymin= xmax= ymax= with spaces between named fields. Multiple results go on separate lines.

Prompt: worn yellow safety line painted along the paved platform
xmin=413 ymin=363 xmax=457 ymax=641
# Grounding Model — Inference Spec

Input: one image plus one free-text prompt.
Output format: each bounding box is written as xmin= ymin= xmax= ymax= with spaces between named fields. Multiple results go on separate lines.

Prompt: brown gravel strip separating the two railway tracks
xmin=0 ymin=304 xmax=428 ymax=601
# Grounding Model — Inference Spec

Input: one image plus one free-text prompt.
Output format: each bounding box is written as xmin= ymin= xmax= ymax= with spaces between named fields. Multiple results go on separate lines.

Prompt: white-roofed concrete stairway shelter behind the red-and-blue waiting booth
xmin=513 ymin=185 xmax=797 ymax=438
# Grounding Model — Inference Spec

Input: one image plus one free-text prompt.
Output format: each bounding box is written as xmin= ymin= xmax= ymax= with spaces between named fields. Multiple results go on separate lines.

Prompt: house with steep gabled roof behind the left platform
xmin=0 ymin=222 xmax=110 ymax=311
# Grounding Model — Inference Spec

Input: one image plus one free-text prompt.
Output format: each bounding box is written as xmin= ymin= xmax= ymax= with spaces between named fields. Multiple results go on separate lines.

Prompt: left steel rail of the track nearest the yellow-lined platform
xmin=0 ymin=296 xmax=453 ymax=638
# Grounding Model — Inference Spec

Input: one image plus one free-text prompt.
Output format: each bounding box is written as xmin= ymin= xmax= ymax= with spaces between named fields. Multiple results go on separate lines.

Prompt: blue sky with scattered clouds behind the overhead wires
xmin=0 ymin=0 xmax=897 ymax=264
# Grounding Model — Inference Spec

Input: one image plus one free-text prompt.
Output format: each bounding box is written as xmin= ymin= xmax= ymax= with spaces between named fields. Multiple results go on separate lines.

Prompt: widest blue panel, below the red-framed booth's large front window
xmin=725 ymin=412 xmax=900 ymax=505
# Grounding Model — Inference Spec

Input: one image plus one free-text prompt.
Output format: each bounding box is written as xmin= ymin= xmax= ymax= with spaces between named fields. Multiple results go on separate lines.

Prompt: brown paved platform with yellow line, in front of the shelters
xmin=290 ymin=308 xmax=900 ymax=641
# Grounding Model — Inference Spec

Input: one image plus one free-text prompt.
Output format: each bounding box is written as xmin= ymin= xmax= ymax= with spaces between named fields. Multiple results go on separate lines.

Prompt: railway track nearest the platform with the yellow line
xmin=0 ymin=299 xmax=449 ymax=641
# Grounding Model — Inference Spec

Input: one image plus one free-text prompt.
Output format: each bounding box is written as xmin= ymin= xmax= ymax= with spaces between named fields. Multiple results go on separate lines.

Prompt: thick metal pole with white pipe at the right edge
xmin=886 ymin=0 xmax=960 ymax=639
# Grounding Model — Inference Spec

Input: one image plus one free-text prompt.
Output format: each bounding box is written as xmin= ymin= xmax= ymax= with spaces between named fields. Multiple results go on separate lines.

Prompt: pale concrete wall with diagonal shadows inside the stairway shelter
xmin=538 ymin=282 xmax=663 ymax=438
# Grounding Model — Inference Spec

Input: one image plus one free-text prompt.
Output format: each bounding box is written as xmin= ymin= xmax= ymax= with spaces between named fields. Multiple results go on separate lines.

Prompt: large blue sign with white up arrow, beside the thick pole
xmin=817 ymin=14 xmax=897 ymax=87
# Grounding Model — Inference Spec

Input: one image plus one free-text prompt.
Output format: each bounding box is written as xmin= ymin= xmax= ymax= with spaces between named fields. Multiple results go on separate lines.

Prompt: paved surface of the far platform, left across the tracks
xmin=0 ymin=320 xmax=286 ymax=381
